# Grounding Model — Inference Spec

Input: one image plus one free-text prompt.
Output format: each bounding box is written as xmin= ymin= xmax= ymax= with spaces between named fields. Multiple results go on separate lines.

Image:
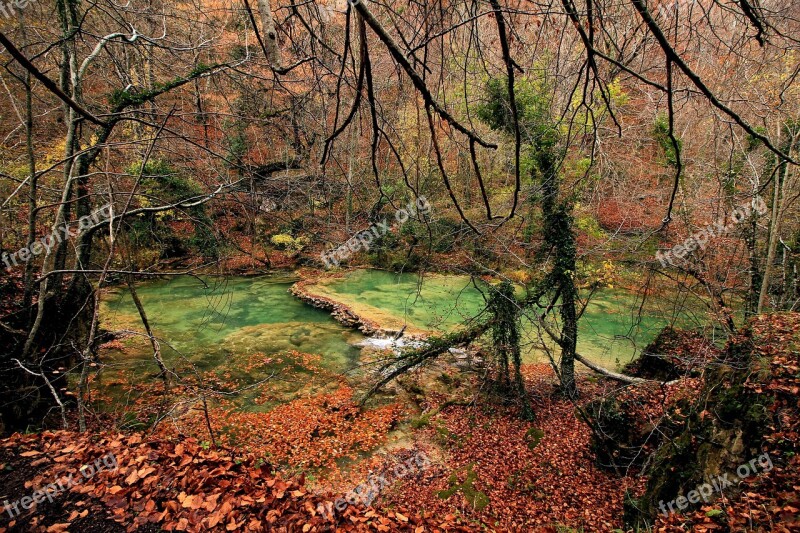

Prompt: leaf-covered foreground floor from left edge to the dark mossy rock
xmin=0 ymin=365 xmax=641 ymax=531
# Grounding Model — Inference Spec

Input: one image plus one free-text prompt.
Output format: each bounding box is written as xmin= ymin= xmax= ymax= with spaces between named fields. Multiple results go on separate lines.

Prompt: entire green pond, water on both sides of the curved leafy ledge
xmin=101 ymin=270 xmax=692 ymax=410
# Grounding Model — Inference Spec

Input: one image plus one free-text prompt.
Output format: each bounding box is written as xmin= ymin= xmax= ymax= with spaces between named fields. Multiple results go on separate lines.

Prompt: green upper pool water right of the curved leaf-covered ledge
xmin=310 ymin=270 xmax=687 ymax=367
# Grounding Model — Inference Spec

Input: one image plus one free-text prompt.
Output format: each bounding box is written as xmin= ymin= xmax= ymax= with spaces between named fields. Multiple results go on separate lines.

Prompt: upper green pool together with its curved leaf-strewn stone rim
xmin=292 ymin=269 xmax=698 ymax=370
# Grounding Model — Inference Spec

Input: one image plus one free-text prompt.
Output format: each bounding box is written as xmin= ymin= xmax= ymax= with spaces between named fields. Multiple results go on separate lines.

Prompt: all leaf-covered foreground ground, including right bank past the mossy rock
xmin=0 ymin=314 xmax=800 ymax=533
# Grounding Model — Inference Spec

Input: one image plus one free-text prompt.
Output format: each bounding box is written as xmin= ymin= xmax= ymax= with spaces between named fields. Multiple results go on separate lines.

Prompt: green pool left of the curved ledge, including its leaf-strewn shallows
xmin=101 ymin=276 xmax=363 ymax=405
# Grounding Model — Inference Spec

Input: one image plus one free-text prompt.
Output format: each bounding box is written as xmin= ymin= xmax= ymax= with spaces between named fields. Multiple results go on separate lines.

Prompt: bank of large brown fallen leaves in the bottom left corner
xmin=0 ymin=432 xmax=430 ymax=532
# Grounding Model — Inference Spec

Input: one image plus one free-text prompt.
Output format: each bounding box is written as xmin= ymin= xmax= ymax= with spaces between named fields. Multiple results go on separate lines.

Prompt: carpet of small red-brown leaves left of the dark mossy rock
xmin=376 ymin=365 xmax=636 ymax=531
